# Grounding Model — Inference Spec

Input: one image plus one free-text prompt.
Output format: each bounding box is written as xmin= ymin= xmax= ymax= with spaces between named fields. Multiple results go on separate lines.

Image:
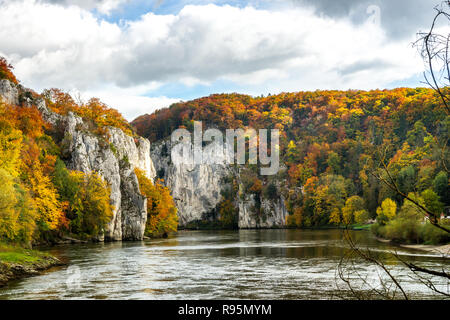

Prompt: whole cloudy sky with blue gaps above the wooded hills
xmin=0 ymin=0 xmax=439 ymax=120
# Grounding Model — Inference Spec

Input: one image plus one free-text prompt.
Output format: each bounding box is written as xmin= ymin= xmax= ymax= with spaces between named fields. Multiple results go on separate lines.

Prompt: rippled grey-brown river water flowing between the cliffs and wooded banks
xmin=0 ymin=230 xmax=450 ymax=299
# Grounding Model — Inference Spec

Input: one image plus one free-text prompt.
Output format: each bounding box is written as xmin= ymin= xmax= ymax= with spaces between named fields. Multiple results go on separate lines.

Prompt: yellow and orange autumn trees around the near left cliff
xmin=0 ymin=58 xmax=177 ymax=246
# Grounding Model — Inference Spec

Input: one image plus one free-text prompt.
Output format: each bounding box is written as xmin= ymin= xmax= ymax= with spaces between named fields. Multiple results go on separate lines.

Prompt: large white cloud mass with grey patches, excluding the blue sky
xmin=0 ymin=0 xmax=422 ymax=118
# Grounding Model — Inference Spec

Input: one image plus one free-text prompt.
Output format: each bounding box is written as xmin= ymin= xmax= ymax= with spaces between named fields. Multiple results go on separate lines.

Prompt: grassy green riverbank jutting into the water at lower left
xmin=0 ymin=244 xmax=64 ymax=287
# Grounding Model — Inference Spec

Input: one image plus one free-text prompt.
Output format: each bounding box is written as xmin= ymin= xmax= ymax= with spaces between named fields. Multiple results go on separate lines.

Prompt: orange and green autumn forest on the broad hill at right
xmin=132 ymin=88 xmax=450 ymax=242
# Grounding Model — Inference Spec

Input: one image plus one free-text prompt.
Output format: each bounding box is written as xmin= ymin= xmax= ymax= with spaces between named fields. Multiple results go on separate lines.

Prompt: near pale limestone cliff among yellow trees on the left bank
xmin=0 ymin=80 xmax=156 ymax=240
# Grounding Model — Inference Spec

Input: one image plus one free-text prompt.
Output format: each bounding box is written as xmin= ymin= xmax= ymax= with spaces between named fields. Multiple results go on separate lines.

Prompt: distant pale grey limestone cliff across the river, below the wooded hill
xmin=151 ymin=140 xmax=288 ymax=228
